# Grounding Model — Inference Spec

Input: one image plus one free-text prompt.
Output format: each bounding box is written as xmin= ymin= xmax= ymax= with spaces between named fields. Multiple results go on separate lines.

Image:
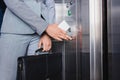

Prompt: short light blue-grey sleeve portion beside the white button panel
xmin=41 ymin=0 xmax=56 ymax=24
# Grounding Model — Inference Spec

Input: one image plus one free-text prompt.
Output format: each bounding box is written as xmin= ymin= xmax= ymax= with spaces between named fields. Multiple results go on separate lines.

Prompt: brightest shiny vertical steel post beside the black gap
xmin=89 ymin=0 xmax=103 ymax=80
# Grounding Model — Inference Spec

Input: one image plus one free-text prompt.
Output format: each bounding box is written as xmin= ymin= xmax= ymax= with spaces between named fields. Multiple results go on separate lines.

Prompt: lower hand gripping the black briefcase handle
xmin=38 ymin=34 xmax=52 ymax=51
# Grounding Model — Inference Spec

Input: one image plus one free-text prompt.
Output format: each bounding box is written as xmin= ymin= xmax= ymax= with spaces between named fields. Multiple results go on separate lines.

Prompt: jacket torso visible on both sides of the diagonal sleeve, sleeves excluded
xmin=1 ymin=0 xmax=41 ymax=34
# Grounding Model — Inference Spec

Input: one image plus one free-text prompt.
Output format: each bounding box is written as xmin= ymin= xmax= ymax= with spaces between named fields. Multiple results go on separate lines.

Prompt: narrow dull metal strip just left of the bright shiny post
xmin=80 ymin=0 xmax=90 ymax=80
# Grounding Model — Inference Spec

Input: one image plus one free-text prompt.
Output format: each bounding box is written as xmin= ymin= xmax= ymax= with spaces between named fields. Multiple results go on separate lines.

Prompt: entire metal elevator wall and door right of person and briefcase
xmin=53 ymin=0 xmax=120 ymax=80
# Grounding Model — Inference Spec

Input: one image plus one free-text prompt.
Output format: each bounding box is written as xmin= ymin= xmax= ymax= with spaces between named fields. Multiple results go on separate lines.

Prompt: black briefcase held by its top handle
xmin=17 ymin=50 xmax=62 ymax=80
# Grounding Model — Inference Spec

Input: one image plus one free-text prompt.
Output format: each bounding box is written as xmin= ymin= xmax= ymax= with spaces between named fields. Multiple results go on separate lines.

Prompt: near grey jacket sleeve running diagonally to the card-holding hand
xmin=4 ymin=0 xmax=48 ymax=35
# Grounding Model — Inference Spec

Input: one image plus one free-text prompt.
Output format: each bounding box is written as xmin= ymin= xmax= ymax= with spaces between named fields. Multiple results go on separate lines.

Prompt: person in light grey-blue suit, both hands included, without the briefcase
xmin=0 ymin=0 xmax=71 ymax=80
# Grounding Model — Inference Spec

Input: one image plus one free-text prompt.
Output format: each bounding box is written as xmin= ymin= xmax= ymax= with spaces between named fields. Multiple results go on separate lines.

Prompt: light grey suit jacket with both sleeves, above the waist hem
xmin=1 ymin=0 xmax=55 ymax=35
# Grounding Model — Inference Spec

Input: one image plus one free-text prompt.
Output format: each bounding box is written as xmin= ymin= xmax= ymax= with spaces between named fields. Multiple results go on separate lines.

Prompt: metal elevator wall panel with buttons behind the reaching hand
xmin=53 ymin=0 xmax=82 ymax=80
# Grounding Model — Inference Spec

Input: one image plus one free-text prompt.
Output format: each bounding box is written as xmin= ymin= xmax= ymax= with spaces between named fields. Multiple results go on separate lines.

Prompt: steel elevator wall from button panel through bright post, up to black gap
xmin=55 ymin=0 xmax=109 ymax=80
